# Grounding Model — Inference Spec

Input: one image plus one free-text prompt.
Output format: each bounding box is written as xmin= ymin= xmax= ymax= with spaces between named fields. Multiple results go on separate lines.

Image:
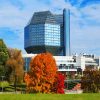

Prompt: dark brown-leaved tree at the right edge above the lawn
xmin=81 ymin=69 xmax=100 ymax=93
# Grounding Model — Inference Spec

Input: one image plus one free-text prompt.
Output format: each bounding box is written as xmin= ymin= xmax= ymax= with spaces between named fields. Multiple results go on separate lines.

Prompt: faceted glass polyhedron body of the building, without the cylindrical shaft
xmin=24 ymin=11 xmax=60 ymax=55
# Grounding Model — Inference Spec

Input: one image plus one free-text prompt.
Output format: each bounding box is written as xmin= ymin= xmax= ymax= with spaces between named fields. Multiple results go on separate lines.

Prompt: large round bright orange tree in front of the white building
xmin=24 ymin=53 xmax=57 ymax=93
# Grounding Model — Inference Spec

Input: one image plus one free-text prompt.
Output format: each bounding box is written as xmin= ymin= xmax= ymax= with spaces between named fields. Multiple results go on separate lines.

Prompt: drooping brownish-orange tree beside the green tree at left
xmin=6 ymin=48 xmax=24 ymax=83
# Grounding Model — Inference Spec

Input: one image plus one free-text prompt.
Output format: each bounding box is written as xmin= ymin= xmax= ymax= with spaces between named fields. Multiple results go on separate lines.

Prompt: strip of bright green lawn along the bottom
xmin=0 ymin=93 xmax=100 ymax=100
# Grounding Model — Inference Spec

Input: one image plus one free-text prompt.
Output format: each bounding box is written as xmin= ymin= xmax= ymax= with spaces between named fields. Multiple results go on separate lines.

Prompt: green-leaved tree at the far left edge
xmin=0 ymin=39 xmax=9 ymax=77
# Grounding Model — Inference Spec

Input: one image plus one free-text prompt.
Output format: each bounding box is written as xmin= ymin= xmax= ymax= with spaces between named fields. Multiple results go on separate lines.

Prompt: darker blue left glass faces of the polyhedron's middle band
xmin=24 ymin=24 xmax=45 ymax=48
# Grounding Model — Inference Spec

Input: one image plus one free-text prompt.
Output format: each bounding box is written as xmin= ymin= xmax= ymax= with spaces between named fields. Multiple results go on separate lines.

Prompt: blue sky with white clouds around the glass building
xmin=0 ymin=0 xmax=100 ymax=55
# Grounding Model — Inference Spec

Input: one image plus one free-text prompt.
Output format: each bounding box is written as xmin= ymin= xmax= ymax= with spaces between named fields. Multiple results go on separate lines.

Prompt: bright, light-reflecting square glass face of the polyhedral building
xmin=45 ymin=24 xmax=60 ymax=46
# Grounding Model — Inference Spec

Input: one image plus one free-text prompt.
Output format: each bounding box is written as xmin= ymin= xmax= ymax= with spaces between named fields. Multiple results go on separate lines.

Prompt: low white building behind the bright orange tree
xmin=23 ymin=54 xmax=100 ymax=73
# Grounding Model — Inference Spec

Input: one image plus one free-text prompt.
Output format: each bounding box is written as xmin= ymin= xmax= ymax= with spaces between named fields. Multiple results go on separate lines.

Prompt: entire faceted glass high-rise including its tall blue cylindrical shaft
xmin=24 ymin=9 xmax=70 ymax=56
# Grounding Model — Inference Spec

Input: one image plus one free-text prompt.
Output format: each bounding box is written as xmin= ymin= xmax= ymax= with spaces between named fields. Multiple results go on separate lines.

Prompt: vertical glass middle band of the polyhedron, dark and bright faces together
xmin=24 ymin=24 xmax=60 ymax=47
